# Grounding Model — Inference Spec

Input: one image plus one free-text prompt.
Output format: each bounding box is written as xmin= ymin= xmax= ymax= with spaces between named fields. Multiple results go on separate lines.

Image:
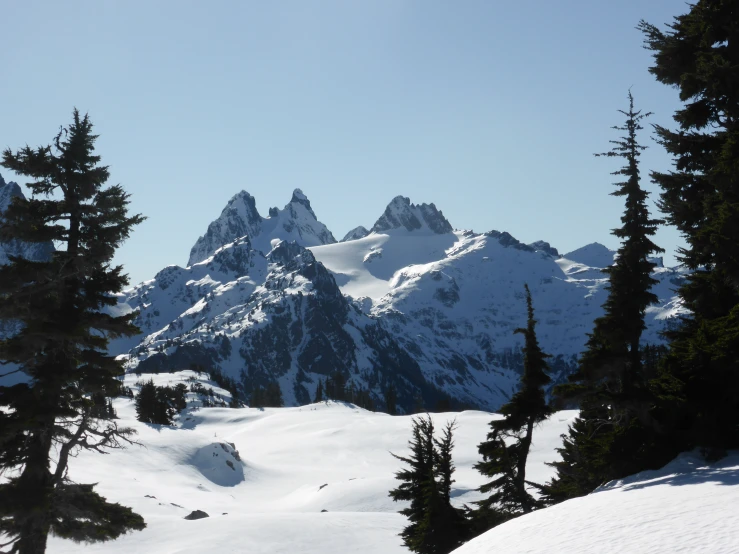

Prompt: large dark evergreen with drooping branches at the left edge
xmin=0 ymin=110 xmax=145 ymax=554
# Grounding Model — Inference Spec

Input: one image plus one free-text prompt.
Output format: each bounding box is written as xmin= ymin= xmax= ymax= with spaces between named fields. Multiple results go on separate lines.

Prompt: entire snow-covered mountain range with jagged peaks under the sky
xmin=113 ymin=190 xmax=684 ymax=409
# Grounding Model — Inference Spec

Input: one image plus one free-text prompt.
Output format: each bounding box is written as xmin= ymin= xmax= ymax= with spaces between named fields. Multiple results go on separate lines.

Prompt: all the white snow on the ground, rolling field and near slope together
xmin=37 ymin=371 xmax=739 ymax=554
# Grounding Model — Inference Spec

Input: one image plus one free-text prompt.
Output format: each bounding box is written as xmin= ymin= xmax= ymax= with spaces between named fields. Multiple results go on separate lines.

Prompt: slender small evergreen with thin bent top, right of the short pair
xmin=474 ymin=285 xmax=552 ymax=520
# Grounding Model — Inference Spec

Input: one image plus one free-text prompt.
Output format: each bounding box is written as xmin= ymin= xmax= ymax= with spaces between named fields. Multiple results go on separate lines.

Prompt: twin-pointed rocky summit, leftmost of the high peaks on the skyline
xmin=187 ymin=189 xmax=336 ymax=266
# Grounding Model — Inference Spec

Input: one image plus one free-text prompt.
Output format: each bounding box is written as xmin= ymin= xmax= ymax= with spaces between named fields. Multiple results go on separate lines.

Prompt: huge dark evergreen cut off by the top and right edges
xmin=640 ymin=0 xmax=739 ymax=457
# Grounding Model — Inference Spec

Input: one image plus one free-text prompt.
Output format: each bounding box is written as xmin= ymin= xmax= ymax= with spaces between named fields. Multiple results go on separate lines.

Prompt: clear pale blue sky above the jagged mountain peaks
xmin=0 ymin=0 xmax=688 ymax=282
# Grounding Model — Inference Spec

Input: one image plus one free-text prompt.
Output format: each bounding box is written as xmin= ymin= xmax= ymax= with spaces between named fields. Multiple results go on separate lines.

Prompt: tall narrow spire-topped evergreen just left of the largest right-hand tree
xmin=545 ymin=91 xmax=667 ymax=501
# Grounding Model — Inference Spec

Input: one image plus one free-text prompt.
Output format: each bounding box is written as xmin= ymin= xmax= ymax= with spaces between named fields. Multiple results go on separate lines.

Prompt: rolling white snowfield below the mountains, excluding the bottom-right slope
xmin=49 ymin=371 xmax=575 ymax=554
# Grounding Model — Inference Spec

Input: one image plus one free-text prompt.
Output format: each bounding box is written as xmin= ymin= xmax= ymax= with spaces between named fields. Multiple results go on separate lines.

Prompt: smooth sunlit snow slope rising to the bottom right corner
xmin=455 ymin=453 xmax=739 ymax=554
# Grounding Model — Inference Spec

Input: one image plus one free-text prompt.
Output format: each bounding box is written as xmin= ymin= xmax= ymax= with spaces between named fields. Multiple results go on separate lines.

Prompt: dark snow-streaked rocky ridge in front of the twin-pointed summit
xmin=113 ymin=238 xmax=439 ymax=406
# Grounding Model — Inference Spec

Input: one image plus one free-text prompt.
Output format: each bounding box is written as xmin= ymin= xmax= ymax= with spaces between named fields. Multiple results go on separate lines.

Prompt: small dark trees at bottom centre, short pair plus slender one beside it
xmin=390 ymin=285 xmax=552 ymax=554
